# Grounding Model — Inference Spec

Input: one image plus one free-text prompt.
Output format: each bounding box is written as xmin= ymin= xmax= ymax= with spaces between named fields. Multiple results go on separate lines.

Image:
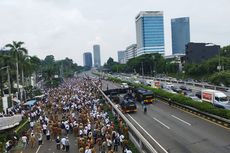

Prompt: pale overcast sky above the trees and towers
xmin=0 ymin=0 xmax=230 ymax=65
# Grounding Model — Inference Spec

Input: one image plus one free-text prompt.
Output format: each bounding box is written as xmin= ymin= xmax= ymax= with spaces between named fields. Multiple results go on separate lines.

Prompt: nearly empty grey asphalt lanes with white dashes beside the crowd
xmin=99 ymin=77 xmax=230 ymax=153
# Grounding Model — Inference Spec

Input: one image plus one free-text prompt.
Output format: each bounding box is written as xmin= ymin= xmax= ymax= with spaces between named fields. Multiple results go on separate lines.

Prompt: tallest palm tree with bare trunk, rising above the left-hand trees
xmin=5 ymin=41 xmax=28 ymax=100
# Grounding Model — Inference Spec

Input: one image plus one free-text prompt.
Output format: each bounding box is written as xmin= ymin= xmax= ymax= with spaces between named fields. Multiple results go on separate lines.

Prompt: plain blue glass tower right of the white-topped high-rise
xmin=171 ymin=17 xmax=190 ymax=54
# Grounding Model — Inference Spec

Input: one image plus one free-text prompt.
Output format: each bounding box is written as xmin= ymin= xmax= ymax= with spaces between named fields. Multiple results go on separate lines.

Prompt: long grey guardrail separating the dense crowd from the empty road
xmin=92 ymin=81 xmax=164 ymax=153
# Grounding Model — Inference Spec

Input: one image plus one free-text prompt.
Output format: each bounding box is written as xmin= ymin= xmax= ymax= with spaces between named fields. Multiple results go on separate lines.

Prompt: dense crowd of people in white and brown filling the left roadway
xmin=4 ymin=77 xmax=131 ymax=153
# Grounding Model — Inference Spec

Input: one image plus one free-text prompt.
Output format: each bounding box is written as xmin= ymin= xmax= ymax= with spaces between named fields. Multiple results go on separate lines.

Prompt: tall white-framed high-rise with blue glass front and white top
xmin=136 ymin=11 xmax=165 ymax=56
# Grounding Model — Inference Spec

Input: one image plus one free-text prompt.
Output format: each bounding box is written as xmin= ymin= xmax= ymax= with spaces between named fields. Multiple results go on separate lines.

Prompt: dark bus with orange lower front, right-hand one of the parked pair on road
xmin=135 ymin=88 xmax=154 ymax=104
